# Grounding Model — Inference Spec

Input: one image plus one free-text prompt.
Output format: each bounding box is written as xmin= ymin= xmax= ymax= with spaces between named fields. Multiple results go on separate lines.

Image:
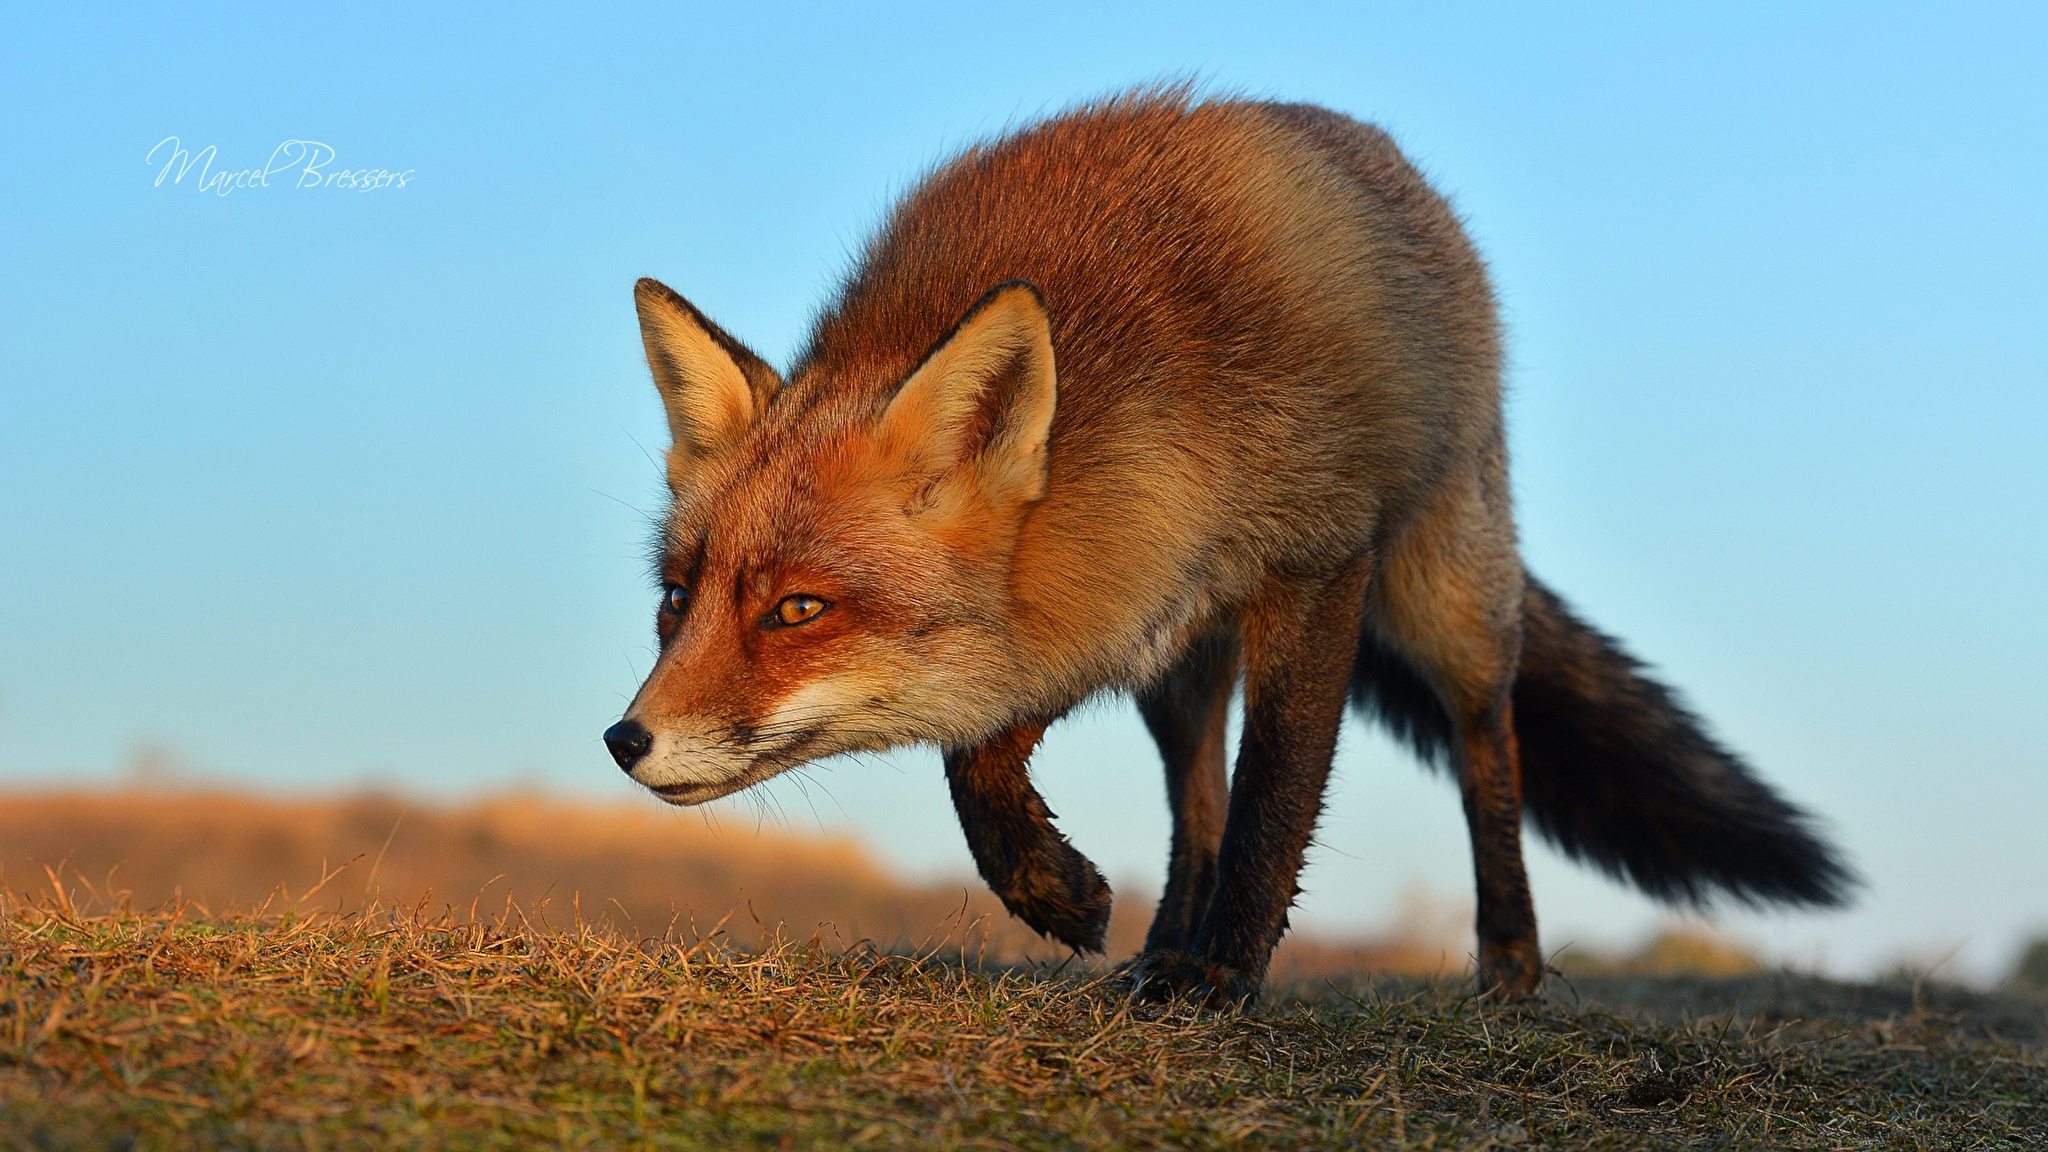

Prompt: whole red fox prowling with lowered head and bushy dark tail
xmin=604 ymin=88 xmax=1855 ymax=1004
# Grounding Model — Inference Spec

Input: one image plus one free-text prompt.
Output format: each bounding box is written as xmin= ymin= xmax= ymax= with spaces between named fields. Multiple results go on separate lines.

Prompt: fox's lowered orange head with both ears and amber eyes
xmin=604 ymin=281 xmax=1057 ymax=804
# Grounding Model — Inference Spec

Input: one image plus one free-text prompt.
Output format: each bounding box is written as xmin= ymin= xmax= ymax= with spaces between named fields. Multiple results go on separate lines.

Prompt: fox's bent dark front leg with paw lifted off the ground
xmin=946 ymin=724 xmax=1110 ymax=951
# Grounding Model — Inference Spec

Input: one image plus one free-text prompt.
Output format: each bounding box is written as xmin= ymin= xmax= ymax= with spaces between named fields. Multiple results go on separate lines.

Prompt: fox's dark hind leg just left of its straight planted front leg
xmin=1139 ymin=627 xmax=1237 ymax=951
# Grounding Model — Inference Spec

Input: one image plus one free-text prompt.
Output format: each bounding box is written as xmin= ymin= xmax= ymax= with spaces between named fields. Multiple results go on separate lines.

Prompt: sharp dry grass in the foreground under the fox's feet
xmin=0 ymin=873 xmax=2048 ymax=1148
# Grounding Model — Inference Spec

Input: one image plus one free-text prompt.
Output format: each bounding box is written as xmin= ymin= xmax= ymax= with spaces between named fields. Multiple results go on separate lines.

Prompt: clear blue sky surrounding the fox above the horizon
xmin=0 ymin=2 xmax=2048 ymax=974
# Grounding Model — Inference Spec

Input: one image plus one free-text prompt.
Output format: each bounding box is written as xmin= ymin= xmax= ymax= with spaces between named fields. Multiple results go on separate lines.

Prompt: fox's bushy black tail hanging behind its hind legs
xmin=1352 ymin=578 xmax=1855 ymax=904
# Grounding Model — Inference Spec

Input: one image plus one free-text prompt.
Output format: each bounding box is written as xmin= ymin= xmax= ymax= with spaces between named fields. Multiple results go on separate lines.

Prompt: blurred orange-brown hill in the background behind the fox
xmin=0 ymin=777 xmax=1468 ymax=980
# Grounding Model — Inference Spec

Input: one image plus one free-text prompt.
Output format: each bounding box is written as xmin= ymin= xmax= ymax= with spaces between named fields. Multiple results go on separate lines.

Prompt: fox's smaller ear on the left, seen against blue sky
xmin=633 ymin=281 xmax=782 ymax=488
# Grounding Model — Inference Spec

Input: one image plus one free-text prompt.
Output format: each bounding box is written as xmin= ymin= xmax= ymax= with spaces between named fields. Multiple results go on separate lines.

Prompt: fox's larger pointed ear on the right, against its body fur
xmin=879 ymin=281 xmax=1057 ymax=502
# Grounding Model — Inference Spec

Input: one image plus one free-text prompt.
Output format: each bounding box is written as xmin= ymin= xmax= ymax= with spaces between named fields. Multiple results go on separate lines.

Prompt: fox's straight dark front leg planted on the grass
xmin=1126 ymin=560 xmax=1368 ymax=1004
